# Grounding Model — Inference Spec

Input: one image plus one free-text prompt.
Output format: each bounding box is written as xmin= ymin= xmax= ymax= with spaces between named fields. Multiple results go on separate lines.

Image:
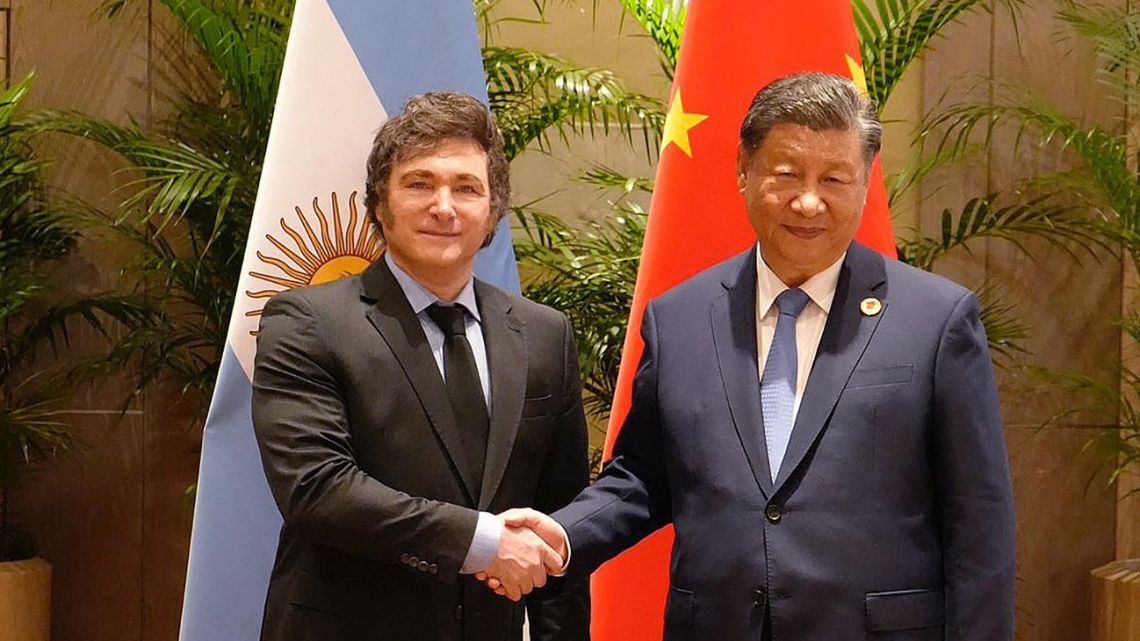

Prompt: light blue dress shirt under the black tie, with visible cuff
xmin=384 ymin=252 xmax=503 ymax=574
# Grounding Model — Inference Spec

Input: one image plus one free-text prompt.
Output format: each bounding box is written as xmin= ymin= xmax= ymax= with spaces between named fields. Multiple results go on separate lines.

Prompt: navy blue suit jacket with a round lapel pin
xmin=554 ymin=243 xmax=1013 ymax=641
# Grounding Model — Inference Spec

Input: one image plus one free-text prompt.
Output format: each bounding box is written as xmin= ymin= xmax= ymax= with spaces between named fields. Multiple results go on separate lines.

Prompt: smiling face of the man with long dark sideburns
xmin=377 ymin=139 xmax=492 ymax=293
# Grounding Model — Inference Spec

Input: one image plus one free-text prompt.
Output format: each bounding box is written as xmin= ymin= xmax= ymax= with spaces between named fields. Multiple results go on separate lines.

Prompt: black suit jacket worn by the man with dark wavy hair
xmin=253 ymin=260 xmax=588 ymax=641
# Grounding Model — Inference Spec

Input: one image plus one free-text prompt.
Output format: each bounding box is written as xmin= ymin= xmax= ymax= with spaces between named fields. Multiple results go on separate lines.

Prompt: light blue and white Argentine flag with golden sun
xmin=180 ymin=0 xmax=519 ymax=641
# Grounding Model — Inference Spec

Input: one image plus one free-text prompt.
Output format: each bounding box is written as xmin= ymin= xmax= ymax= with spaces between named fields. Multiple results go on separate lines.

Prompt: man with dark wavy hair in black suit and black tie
xmin=253 ymin=92 xmax=588 ymax=641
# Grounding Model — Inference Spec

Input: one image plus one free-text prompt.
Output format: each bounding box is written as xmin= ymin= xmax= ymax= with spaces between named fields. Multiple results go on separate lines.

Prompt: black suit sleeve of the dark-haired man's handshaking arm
xmin=253 ymin=291 xmax=478 ymax=582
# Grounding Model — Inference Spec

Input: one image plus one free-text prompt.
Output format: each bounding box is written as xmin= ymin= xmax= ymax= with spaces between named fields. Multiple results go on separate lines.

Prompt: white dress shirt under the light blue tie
xmin=756 ymin=250 xmax=847 ymax=431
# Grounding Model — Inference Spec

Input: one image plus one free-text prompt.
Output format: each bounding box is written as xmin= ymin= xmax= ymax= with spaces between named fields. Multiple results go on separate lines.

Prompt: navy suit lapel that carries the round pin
xmin=775 ymin=243 xmax=888 ymax=492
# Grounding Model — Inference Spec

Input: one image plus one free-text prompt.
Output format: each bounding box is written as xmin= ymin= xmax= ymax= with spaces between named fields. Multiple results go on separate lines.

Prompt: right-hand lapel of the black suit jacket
xmin=475 ymin=279 xmax=527 ymax=510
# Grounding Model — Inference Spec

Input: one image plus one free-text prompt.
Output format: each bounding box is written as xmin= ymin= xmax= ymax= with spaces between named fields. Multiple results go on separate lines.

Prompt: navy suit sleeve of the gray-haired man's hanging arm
xmin=931 ymin=293 xmax=1015 ymax=641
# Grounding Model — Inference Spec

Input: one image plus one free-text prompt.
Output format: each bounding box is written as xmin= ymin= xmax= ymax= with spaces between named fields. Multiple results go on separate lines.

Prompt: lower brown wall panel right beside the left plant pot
xmin=17 ymin=412 xmax=144 ymax=641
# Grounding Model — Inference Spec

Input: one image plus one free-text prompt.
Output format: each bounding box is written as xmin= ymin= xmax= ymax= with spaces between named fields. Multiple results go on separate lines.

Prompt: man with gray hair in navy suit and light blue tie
xmin=487 ymin=73 xmax=1013 ymax=641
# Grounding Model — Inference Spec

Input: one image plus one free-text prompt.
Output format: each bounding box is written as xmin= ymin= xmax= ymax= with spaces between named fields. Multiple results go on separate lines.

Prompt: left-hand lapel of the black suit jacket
xmin=361 ymin=260 xmax=478 ymax=505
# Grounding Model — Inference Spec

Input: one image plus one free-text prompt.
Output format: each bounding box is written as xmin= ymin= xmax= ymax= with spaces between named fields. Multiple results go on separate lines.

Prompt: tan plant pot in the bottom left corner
xmin=0 ymin=559 xmax=51 ymax=641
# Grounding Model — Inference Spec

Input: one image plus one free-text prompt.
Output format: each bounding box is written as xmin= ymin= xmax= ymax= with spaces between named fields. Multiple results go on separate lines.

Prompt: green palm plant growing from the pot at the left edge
xmin=0 ymin=78 xmax=139 ymax=561
